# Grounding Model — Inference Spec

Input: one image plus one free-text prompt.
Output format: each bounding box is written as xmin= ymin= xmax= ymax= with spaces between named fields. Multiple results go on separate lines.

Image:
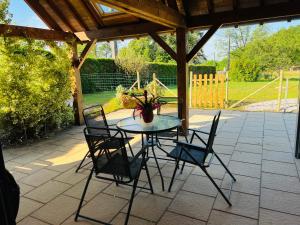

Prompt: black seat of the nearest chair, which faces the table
xmin=96 ymin=152 xmax=142 ymax=179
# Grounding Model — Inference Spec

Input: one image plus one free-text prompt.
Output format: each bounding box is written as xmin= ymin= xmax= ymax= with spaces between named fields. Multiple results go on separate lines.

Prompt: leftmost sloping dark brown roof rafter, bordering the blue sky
xmin=24 ymin=0 xmax=62 ymax=30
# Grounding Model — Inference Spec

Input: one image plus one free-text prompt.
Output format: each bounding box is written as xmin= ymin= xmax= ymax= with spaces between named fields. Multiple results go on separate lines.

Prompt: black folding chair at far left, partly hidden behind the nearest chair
xmin=76 ymin=105 xmax=133 ymax=173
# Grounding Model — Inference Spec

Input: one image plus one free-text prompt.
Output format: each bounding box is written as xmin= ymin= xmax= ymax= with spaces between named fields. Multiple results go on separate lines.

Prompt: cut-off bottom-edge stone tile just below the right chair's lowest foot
xmin=207 ymin=210 xmax=257 ymax=225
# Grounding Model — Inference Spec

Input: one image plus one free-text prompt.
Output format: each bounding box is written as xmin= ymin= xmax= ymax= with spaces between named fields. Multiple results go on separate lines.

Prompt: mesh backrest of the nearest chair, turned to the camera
xmin=84 ymin=127 xmax=132 ymax=179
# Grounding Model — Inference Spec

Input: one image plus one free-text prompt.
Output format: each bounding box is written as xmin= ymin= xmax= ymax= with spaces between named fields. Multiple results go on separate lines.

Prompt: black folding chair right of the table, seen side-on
xmin=168 ymin=111 xmax=236 ymax=206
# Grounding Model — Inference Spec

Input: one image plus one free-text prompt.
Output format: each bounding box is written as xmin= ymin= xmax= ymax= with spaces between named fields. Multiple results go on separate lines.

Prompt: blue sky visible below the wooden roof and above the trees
xmin=9 ymin=0 xmax=300 ymax=60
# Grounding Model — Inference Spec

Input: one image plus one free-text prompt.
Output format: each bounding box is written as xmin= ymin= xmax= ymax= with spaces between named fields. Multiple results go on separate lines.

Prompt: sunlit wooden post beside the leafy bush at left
xmin=72 ymin=42 xmax=84 ymax=125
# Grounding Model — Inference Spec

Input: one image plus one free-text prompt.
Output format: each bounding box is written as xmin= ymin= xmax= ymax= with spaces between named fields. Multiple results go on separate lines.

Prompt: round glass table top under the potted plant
xmin=117 ymin=115 xmax=181 ymax=134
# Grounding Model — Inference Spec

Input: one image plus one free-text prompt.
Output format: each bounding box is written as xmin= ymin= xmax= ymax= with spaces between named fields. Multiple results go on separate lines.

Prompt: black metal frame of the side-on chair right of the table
xmin=168 ymin=111 xmax=236 ymax=206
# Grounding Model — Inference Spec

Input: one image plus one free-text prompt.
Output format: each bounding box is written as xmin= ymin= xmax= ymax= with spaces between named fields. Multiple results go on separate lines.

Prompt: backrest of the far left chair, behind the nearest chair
xmin=82 ymin=105 xmax=110 ymax=135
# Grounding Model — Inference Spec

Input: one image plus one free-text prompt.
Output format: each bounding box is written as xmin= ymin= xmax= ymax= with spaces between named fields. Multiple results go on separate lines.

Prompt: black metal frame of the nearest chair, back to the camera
xmin=75 ymin=128 xmax=153 ymax=225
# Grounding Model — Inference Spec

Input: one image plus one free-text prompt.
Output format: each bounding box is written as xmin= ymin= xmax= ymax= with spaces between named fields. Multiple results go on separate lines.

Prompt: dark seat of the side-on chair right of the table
xmin=168 ymin=145 xmax=205 ymax=165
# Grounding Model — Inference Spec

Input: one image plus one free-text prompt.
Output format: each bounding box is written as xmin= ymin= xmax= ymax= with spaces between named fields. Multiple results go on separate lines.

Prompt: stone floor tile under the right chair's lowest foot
xmin=214 ymin=191 xmax=259 ymax=219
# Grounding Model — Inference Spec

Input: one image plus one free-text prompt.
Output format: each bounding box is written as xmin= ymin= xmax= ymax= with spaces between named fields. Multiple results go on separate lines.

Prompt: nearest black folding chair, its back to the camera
xmin=75 ymin=127 xmax=153 ymax=225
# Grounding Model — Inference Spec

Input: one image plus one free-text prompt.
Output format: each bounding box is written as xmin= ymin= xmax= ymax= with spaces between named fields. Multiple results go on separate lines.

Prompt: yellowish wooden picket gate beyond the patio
xmin=190 ymin=74 xmax=225 ymax=108
